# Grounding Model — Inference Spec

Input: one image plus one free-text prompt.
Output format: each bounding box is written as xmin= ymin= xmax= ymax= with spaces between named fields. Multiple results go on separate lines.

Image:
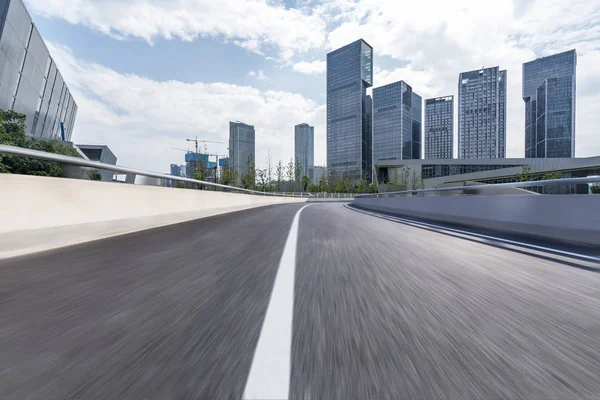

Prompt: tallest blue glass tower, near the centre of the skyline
xmin=327 ymin=39 xmax=373 ymax=182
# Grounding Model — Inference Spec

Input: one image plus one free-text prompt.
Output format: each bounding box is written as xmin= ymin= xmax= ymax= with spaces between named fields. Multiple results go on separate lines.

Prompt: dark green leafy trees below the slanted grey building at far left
xmin=0 ymin=109 xmax=79 ymax=176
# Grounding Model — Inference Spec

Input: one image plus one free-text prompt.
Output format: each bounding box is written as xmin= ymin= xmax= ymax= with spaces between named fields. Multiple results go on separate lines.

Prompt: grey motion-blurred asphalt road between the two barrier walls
xmin=0 ymin=204 xmax=600 ymax=399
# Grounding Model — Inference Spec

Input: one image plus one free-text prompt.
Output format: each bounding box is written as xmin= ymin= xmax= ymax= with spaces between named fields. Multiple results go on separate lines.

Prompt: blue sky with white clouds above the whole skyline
xmin=25 ymin=0 xmax=600 ymax=172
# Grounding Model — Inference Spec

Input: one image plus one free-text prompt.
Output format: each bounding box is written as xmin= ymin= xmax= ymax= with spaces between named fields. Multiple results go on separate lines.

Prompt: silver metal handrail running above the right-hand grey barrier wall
xmin=356 ymin=177 xmax=600 ymax=197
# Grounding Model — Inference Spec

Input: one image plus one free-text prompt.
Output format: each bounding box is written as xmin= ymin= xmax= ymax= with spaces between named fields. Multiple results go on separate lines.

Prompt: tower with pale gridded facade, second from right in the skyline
xmin=458 ymin=67 xmax=506 ymax=158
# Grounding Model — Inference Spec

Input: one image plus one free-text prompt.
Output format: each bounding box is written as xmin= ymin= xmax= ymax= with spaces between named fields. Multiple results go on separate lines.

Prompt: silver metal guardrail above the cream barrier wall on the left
xmin=0 ymin=145 xmax=296 ymax=197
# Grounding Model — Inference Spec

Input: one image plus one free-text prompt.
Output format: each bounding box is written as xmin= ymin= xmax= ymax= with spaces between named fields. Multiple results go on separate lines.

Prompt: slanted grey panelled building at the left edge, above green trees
xmin=0 ymin=0 xmax=77 ymax=141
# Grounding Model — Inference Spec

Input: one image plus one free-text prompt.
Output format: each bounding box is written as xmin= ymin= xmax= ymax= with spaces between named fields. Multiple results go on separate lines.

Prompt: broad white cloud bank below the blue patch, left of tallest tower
xmin=49 ymin=43 xmax=325 ymax=172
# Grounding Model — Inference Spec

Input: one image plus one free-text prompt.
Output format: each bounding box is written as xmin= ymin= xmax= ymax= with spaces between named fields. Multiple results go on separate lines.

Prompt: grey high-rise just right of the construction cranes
xmin=229 ymin=121 xmax=256 ymax=183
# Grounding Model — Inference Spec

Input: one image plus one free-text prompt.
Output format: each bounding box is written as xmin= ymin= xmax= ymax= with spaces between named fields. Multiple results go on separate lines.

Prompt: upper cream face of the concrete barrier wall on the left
xmin=0 ymin=174 xmax=306 ymax=233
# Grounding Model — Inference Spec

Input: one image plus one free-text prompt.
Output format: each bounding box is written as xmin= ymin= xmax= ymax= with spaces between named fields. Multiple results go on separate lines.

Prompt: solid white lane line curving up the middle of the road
xmin=244 ymin=204 xmax=311 ymax=400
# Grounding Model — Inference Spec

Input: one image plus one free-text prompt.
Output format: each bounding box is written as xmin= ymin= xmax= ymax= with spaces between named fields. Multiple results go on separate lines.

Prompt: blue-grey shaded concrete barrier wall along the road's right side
xmin=353 ymin=195 xmax=600 ymax=246
